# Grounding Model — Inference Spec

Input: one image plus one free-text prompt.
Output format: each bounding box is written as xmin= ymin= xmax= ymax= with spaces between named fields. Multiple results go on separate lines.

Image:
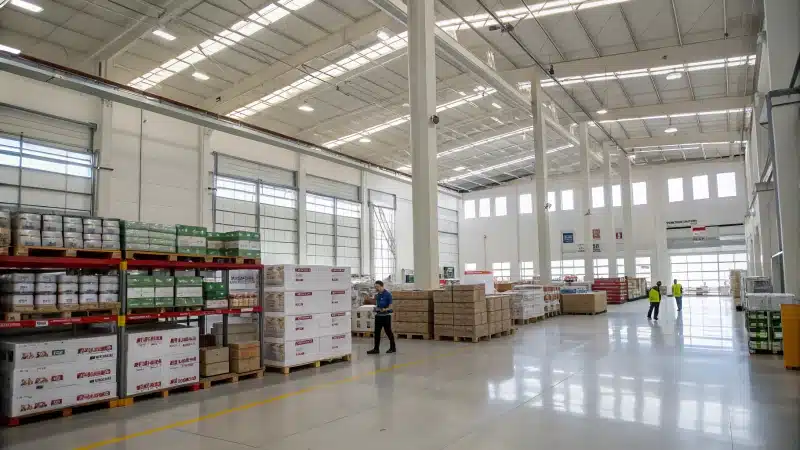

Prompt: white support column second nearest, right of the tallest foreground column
xmin=531 ymin=72 xmax=552 ymax=283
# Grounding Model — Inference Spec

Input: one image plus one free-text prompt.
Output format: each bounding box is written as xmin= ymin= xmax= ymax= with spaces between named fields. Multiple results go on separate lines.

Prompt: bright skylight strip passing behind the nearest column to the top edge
xmin=227 ymin=0 xmax=631 ymax=119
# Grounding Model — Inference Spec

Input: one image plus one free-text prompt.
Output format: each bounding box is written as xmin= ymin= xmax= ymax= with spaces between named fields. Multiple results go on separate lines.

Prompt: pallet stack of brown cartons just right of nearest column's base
xmin=433 ymin=284 xmax=489 ymax=342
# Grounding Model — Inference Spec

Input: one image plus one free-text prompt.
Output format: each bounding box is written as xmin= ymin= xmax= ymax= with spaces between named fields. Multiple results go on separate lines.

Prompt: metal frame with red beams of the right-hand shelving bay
xmin=117 ymin=260 xmax=264 ymax=398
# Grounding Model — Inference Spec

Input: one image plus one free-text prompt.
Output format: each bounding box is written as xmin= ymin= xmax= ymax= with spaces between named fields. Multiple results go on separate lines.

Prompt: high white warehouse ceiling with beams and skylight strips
xmin=0 ymin=0 xmax=761 ymax=190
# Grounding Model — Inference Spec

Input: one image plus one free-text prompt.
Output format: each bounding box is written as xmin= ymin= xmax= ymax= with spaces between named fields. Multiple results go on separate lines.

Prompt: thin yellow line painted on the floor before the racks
xmin=74 ymin=346 xmax=471 ymax=450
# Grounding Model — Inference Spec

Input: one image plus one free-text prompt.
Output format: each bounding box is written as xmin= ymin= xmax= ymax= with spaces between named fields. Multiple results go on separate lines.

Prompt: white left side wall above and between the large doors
xmin=0 ymin=72 xmax=460 ymax=279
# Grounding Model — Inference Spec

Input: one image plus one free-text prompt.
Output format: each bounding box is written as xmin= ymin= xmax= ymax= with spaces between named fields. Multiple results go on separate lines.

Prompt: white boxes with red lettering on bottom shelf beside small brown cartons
xmin=125 ymin=324 xmax=200 ymax=396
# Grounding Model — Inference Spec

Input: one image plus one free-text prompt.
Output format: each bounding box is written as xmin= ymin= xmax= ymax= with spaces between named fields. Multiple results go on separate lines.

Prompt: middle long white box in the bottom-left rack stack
xmin=0 ymin=360 xmax=117 ymax=395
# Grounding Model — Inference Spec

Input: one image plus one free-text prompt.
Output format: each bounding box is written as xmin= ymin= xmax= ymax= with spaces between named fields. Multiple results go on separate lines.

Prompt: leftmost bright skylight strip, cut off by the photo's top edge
xmin=128 ymin=0 xmax=314 ymax=90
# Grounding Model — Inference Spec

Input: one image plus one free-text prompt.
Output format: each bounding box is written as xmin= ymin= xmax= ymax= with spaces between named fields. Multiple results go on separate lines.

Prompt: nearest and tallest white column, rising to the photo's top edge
xmin=408 ymin=0 xmax=439 ymax=289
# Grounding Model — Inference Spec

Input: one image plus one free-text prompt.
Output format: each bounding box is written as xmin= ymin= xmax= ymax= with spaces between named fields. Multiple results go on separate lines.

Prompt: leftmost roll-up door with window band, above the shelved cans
xmin=0 ymin=105 xmax=94 ymax=215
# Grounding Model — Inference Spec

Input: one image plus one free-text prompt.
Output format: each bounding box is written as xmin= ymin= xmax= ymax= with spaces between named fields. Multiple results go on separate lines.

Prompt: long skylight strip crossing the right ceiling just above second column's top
xmin=517 ymin=55 xmax=756 ymax=91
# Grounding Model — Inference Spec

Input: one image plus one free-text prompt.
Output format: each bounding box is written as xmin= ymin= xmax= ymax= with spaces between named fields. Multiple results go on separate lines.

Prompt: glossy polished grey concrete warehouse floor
xmin=0 ymin=297 xmax=800 ymax=450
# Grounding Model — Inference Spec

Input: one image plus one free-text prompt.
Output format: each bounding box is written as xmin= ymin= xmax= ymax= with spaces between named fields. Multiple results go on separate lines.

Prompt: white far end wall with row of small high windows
xmin=459 ymin=160 xmax=746 ymax=278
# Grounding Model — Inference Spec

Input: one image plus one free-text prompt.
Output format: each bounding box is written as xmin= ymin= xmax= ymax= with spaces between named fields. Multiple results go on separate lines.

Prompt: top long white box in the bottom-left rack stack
xmin=0 ymin=334 xmax=117 ymax=370
